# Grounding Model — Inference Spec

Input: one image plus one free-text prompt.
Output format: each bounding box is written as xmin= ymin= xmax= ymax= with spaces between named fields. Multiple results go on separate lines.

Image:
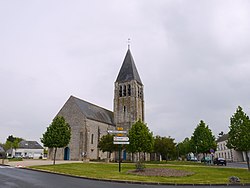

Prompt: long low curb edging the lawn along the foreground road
xmin=19 ymin=167 xmax=250 ymax=187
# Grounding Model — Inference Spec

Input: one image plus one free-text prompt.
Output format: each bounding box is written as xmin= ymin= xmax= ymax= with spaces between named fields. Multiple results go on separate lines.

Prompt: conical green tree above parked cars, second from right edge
xmin=190 ymin=120 xmax=217 ymax=156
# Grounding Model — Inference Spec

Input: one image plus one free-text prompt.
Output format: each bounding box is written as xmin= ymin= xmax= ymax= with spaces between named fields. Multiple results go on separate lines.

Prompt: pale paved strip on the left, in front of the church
xmin=7 ymin=159 xmax=82 ymax=167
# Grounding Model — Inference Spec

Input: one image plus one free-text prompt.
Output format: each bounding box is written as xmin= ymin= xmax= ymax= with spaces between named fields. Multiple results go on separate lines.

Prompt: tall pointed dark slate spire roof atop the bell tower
xmin=116 ymin=49 xmax=142 ymax=84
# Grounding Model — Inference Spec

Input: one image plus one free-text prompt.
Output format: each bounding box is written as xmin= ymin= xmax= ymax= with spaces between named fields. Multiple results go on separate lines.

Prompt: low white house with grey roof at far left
xmin=7 ymin=140 xmax=43 ymax=159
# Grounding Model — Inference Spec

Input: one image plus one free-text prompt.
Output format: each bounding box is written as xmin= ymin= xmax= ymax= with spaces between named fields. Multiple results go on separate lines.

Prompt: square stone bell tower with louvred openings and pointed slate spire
xmin=114 ymin=48 xmax=144 ymax=130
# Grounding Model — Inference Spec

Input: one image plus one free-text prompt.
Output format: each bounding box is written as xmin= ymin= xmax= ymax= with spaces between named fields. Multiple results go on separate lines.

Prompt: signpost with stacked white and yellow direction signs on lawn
xmin=108 ymin=127 xmax=129 ymax=172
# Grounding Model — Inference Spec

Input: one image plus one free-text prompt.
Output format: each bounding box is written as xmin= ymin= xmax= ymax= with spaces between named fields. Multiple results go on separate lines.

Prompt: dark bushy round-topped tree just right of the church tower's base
xmin=154 ymin=136 xmax=176 ymax=161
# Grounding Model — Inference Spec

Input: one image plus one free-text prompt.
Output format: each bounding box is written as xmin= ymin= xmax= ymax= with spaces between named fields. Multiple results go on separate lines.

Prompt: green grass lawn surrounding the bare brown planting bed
xmin=30 ymin=163 xmax=250 ymax=184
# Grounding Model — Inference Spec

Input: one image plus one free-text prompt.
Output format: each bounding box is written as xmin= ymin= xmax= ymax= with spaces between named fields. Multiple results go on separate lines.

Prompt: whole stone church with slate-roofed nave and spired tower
xmin=48 ymin=48 xmax=144 ymax=160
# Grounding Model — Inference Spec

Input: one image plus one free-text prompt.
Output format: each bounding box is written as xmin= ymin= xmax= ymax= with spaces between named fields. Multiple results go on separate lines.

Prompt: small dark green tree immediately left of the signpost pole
xmin=98 ymin=134 xmax=118 ymax=158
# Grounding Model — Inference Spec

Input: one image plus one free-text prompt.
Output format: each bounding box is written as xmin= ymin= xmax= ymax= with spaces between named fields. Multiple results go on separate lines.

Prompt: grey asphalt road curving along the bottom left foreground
xmin=0 ymin=166 xmax=246 ymax=188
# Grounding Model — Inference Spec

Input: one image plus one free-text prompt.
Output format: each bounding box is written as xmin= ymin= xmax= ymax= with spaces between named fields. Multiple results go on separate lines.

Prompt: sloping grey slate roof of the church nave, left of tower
xmin=71 ymin=96 xmax=114 ymax=125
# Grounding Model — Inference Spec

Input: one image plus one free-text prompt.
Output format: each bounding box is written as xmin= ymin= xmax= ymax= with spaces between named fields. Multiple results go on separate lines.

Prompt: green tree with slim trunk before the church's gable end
xmin=41 ymin=116 xmax=71 ymax=164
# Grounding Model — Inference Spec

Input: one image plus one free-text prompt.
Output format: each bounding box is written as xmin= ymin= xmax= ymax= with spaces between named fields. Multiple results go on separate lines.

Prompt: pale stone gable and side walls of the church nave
xmin=48 ymin=98 xmax=114 ymax=160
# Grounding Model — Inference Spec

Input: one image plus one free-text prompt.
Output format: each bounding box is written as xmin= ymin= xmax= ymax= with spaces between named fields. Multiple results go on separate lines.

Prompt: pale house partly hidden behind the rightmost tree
xmin=215 ymin=134 xmax=244 ymax=162
